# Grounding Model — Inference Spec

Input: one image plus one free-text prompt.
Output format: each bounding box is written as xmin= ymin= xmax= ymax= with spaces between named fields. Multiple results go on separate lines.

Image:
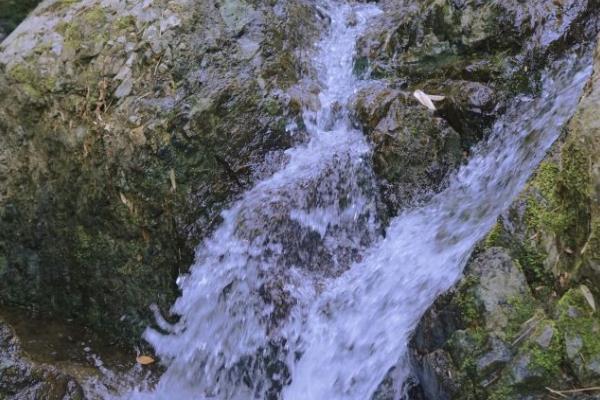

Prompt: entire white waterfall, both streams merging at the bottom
xmin=106 ymin=0 xmax=591 ymax=400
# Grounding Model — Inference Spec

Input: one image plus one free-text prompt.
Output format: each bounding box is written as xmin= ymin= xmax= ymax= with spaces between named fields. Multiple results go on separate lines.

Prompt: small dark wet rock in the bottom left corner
xmin=0 ymin=319 xmax=84 ymax=400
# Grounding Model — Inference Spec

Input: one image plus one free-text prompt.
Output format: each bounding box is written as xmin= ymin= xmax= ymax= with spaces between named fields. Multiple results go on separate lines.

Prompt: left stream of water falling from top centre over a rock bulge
xmin=124 ymin=1 xmax=381 ymax=400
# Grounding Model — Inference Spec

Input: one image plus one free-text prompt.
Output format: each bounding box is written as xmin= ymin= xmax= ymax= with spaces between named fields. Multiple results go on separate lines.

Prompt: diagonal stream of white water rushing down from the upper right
xmin=284 ymin=52 xmax=592 ymax=400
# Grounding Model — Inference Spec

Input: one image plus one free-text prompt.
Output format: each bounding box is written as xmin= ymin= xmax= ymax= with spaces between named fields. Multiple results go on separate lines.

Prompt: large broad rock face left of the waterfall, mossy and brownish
xmin=0 ymin=0 xmax=325 ymax=341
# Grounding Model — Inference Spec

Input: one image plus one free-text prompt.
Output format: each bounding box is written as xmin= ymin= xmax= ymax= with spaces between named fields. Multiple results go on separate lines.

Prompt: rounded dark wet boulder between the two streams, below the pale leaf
xmin=354 ymin=85 xmax=462 ymax=214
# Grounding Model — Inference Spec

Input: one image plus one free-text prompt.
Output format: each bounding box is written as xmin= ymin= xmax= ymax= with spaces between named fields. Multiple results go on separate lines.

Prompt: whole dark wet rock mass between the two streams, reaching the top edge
xmin=355 ymin=0 xmax=598 ymax=215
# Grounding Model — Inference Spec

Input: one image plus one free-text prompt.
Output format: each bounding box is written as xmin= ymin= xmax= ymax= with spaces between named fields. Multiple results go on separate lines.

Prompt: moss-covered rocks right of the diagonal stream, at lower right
xmin=411 ymin=36 xmax=600 ymax=399
